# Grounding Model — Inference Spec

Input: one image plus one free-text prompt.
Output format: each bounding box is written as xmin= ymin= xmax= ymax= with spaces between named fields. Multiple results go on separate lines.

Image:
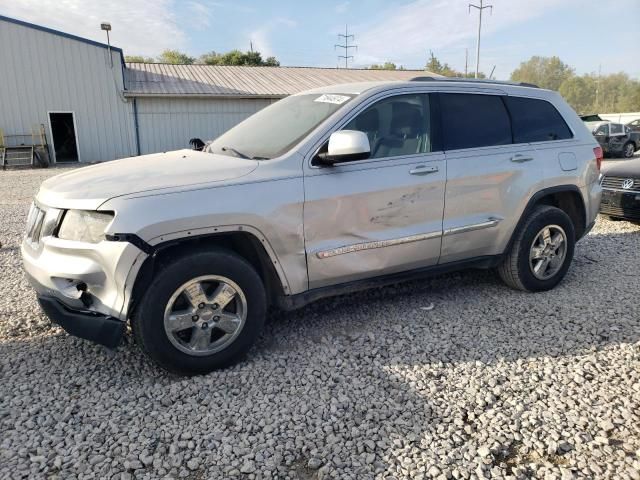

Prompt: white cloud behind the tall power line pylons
xmin=353 ymin=0 xmax=577 ymax=67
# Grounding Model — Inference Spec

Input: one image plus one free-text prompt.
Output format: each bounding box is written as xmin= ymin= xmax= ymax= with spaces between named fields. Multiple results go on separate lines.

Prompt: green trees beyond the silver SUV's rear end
xmin=511 ymin=56 xmax=640 ymax=113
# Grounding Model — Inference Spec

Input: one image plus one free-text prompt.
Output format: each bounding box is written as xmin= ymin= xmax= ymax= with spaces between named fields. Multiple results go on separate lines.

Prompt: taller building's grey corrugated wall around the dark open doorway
xmin=0 ymin=19 xmax=136 ymax=162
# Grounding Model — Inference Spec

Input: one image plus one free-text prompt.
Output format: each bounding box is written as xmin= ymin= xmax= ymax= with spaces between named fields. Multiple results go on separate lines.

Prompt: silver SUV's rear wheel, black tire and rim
xmin=498 ymin=205 xmax=575 ymax=292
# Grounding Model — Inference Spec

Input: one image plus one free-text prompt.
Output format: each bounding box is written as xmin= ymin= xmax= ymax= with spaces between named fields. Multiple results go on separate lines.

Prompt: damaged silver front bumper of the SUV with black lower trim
xmin=21 ymin=202 xmax=147 ymax=348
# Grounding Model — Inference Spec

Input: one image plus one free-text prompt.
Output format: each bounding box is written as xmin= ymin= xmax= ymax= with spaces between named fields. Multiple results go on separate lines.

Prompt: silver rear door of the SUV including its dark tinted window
xmin=438 ymin=93 xmax=542 ymax=263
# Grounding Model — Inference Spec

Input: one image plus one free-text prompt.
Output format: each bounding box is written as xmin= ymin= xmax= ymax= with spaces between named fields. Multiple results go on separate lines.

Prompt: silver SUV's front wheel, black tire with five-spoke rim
xmin=131 ymin=249 xmax=267 ymax=375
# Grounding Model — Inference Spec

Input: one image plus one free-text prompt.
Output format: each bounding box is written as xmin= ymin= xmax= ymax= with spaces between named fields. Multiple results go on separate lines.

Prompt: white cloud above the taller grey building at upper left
xmin=0 ymin=0 xmax=186 ymax=56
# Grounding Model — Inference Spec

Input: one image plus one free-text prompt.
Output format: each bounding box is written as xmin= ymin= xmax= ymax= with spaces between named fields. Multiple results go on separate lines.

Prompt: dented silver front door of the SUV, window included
xmin=304 ymin=94 xmax=446 ymax=289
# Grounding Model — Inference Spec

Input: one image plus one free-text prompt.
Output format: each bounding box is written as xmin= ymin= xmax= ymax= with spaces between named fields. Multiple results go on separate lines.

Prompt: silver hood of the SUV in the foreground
xmin=37 ymin=150 xmax=258 ymax=209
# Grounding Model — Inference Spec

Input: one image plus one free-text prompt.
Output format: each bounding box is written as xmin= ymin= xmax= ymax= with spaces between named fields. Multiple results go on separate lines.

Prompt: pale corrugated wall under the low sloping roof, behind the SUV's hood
xmin=137 ymin=97 xmax=276 ymax=154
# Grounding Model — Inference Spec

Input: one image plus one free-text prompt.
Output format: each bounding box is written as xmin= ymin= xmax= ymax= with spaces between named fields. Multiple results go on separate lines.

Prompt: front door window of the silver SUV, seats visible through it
xmin=343 ymin=94 xmax=431 ymax=158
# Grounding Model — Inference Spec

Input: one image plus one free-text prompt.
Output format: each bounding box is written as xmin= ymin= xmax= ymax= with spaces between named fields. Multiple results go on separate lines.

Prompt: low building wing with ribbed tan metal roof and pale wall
xmin=125 ymin=63 xmax=424 ymax=153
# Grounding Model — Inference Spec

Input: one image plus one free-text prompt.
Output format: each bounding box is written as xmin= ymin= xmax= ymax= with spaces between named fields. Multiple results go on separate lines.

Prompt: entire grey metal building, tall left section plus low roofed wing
xmin=0 ymin=16 xmax=425 ymax=162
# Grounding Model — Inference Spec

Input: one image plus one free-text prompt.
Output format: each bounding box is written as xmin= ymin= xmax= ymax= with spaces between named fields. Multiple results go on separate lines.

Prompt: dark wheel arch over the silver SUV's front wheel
xmin=126 ymin=230 xmax=289 ymax=317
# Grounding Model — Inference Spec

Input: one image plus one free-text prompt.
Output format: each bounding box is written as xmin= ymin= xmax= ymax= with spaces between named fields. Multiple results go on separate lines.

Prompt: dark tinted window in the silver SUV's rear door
xmin=440 ymin=93 xmax=511 ymax=150
